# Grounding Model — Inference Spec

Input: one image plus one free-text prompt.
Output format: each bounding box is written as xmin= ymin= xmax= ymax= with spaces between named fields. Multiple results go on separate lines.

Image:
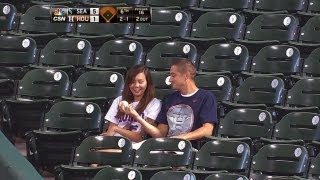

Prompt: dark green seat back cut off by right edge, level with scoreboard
xmin=299 ymin=16 xmax=320 ymax=43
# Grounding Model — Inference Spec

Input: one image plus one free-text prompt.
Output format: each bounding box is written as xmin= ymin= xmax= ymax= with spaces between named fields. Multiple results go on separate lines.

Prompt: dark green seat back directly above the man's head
xmin=146 ymin=41 xmax=198 ymax=71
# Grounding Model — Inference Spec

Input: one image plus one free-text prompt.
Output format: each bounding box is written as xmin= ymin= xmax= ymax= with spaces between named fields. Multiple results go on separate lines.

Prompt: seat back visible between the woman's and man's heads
xmin=151 ymin=71 xmax=174 ymax=99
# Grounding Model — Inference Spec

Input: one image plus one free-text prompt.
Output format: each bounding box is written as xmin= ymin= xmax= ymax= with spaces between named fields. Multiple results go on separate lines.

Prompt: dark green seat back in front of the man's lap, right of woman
xmin=134 ymin=138 xmax=192 ymax=167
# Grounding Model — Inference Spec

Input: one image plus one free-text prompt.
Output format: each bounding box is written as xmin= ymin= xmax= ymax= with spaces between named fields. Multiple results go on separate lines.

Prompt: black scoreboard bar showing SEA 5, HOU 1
xmin=50 ymin=6 xmax=151 ymax=23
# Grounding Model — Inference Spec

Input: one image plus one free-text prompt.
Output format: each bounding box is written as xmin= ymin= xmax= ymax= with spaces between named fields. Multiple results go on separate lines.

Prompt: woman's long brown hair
xmin=116 ymin=65 xmax=155 ymax=118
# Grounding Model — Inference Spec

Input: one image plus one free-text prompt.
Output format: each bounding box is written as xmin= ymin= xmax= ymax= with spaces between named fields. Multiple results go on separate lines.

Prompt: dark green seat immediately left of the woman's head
xmin=63 ymin=71 xmax=124 ymax=113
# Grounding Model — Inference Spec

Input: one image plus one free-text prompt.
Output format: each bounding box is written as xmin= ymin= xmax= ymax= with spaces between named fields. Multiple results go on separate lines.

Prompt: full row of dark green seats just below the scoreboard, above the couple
xmin=0 ymin=36 xmax=320 ymax=88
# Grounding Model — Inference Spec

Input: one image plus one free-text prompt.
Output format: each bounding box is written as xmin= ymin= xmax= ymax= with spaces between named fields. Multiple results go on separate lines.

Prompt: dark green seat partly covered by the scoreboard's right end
xmin=127 ymin=8 xmax=192 ymax=52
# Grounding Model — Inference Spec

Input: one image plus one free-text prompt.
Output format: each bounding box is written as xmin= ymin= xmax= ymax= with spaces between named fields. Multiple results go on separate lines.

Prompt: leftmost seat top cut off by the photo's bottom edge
xmin=92 ymin=167 xmax=142 ymax=180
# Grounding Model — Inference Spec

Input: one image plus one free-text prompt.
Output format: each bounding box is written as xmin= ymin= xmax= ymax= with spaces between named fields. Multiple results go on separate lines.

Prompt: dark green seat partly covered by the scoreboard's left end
xmin=18 ymin=5 xmax=75 ymax=48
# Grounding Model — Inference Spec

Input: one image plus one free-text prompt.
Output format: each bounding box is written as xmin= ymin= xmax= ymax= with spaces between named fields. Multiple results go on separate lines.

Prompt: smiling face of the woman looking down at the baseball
xmin=129 ymin=73 xmax=148 ymax=101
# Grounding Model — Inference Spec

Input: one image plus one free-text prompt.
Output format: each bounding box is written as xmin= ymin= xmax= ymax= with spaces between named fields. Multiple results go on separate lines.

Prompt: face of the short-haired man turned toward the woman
xmin=169 ymin=66 xmax=186 ymax=91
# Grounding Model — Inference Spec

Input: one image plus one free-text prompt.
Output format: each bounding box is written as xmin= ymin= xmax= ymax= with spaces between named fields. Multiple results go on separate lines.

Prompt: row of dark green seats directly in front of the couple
xmin=27 ymin=134 xmax=320 ymax=180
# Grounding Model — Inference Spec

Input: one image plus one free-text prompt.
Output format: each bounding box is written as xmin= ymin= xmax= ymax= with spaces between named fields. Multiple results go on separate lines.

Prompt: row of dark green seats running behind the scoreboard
xmin=2 ymin=6 xmax=320 ymax=53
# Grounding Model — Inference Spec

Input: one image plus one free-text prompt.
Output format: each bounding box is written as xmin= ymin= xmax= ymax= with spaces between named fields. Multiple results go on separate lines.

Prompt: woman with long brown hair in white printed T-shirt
xmin=104 ymin=65 xmax=161 ymax=142
